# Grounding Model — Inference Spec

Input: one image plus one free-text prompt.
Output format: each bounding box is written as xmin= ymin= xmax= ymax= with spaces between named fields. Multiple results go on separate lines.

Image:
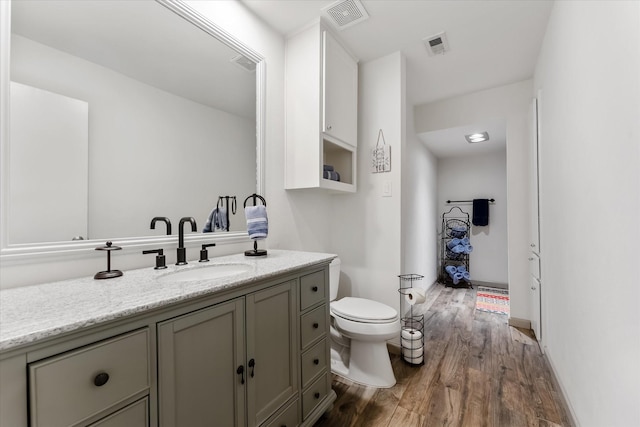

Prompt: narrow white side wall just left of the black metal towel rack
xmin=401 ymin=106 xmax=439 ymax=288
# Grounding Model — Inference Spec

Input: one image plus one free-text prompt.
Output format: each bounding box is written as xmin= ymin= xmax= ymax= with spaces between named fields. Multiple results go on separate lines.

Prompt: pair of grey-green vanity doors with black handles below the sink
xmin=158 ymin=281 xmax=298 ymax=427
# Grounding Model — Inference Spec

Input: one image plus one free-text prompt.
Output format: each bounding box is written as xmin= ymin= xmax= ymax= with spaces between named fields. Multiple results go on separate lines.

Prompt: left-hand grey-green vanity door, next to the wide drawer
xmin=158 ymin=298 xmax=246 ymax=427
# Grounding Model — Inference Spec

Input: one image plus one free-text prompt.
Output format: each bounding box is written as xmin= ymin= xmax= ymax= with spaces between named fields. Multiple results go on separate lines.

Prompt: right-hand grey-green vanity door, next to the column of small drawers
xmin=246 ymin=281 xmax=298 ymax=427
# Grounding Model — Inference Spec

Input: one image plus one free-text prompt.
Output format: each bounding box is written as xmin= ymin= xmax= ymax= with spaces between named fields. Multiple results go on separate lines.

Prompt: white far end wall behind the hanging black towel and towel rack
xmin=437 ymin=150 xmax=508 ymax=284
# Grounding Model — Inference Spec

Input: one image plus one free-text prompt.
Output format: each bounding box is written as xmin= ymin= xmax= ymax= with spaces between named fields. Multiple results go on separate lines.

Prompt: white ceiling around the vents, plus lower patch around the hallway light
xmin=242 ymin=0 xmax=553 ymax=157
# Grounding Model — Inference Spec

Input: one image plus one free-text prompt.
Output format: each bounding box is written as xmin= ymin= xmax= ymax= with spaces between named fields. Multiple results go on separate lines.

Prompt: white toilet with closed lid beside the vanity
xmin=329 ymin=258 xmax=400 ymax=388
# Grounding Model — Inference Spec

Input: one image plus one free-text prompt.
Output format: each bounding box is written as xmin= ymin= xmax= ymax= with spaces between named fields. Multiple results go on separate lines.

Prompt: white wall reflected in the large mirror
xmin=11 ymin=34 xmax=256 ymax=242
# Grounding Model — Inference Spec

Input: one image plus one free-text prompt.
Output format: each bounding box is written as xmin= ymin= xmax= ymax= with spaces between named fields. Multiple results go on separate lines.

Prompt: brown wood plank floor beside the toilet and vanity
xmin=314 ymin=284 xmax=570 ymax=427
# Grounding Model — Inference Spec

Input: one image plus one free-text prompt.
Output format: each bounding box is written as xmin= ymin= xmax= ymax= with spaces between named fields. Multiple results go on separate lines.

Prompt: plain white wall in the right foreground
xmin=535 ymin=1 xmax=640 ymax=427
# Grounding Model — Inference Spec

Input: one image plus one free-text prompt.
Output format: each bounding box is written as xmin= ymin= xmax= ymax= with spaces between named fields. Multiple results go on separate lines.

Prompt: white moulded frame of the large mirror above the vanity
xmin=0 ymin=0 xmax=266 ymax=263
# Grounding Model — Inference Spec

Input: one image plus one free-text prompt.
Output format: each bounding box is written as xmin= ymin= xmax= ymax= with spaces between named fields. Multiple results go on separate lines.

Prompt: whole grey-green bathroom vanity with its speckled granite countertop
xmin=0 ymin=250 xmax=336 ymax=427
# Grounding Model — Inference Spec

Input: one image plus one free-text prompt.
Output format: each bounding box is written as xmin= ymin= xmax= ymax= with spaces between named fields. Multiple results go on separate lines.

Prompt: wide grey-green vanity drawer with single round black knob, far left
xmin=29 ymin=329 xmax=149 ymax=427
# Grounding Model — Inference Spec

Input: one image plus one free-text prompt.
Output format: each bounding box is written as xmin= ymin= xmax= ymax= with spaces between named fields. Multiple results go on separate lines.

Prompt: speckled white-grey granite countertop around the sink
xmin=0 ymin=249 xmax=335 ymax=352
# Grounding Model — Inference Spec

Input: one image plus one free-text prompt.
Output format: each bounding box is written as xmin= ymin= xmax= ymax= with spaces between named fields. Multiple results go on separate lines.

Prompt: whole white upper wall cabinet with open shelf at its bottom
xmin=285 ymin=22 xmax=358 ymax=192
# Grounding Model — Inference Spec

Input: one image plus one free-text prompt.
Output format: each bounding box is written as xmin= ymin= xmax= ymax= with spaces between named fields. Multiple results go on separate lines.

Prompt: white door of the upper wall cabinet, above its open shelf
xmin=322 ymin=31 xmax=358 ymax=147
